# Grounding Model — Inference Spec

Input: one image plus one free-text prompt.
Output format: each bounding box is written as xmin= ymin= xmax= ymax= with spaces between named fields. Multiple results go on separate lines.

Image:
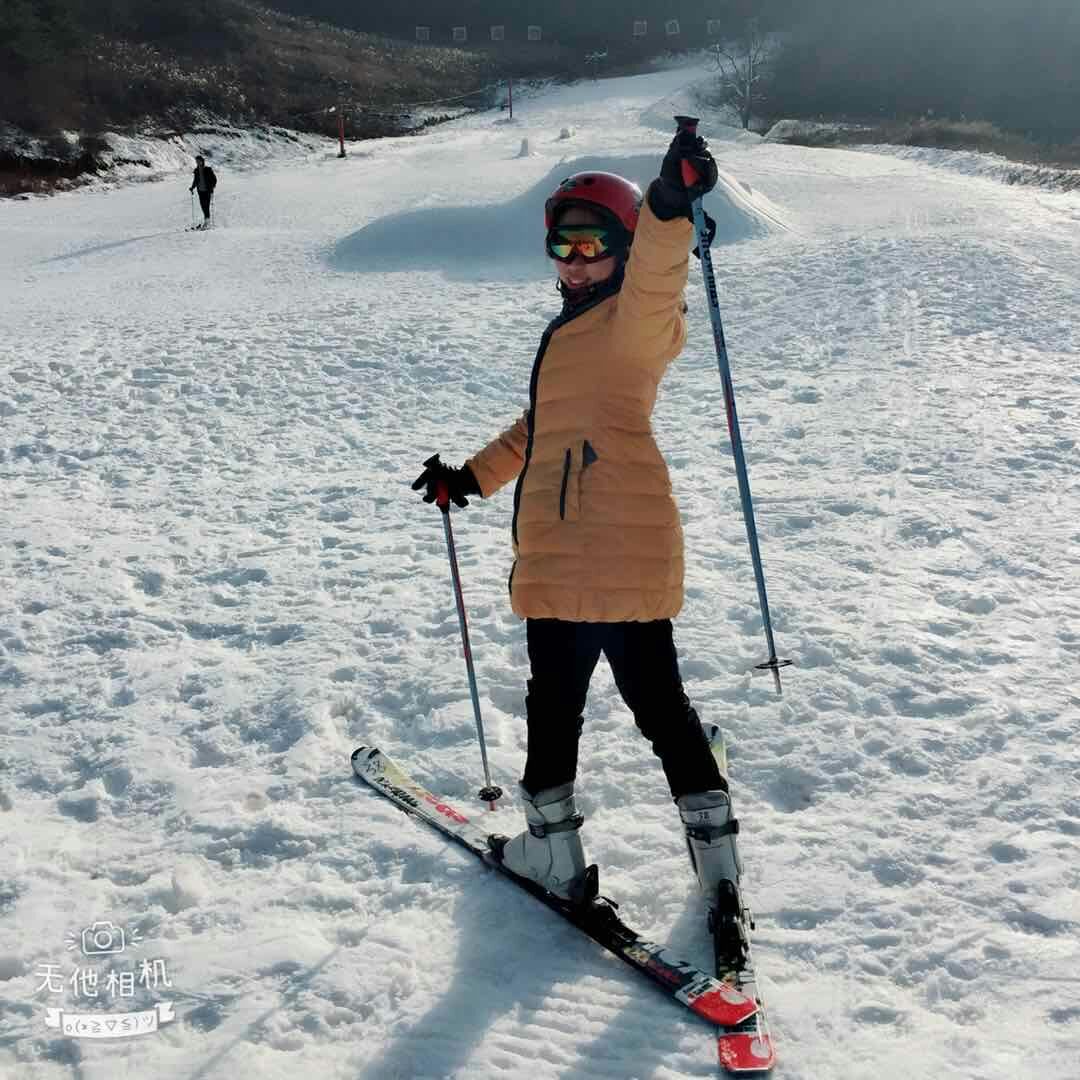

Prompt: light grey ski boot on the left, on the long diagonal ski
xmin=497 ymin=782 xmax=596 ymax=904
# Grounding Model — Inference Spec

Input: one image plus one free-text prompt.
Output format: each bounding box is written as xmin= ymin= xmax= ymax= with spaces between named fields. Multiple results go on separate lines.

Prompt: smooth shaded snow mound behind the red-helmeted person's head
xmin=329 ymin=153 xmax=784 ymax=278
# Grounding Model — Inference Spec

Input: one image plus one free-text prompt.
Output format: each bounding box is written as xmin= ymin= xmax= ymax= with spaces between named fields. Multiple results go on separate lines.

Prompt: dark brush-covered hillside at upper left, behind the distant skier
xmin=0 ymin=0 xmax=496 ymax=192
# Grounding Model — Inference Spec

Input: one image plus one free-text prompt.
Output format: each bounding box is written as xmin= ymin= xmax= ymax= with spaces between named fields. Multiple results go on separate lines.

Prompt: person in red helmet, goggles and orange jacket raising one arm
xmin=413 ymin=133 xmax=739 ymax=908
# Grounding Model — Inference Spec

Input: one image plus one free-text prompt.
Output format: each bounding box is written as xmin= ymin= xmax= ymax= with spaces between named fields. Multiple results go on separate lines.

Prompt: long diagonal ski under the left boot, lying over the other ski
xmin=352 ymin=746 xmax=757 ymax=1031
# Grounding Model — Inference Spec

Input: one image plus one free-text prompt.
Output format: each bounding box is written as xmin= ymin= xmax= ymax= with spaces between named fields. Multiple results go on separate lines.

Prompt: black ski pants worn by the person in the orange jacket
xmin=522 ymin=619 xmax=727 ymax=799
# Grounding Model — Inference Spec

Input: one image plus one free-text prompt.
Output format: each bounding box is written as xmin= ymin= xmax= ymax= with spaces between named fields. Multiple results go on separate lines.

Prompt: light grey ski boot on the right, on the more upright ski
xmin=676 ymin=791 xmax=754 ymax=970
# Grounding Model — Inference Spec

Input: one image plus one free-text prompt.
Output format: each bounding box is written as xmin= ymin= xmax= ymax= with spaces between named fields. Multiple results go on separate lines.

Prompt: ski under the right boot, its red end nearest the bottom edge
xmin=703 ymin=724 xmax=777 ymax=1075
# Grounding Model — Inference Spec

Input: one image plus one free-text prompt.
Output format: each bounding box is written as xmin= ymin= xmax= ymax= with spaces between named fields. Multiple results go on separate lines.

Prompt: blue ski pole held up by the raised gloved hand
xmin=675 ymin=117 xmax=792 ymax=694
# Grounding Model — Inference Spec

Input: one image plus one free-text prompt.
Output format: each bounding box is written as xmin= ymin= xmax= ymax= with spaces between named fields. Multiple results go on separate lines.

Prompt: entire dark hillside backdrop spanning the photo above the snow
xmin=0 ymin=0 xmax=1080 ymax=194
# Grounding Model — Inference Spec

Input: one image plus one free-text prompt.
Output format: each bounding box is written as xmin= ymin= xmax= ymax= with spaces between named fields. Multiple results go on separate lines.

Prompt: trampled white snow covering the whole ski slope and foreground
xmin=0 ymin=63 xmax=1080 ymax=1080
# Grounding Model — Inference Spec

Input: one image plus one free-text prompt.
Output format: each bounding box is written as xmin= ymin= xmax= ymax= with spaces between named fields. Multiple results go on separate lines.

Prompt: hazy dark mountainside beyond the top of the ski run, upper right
xmin=250 ymin=0 xmax=1080 ymax=138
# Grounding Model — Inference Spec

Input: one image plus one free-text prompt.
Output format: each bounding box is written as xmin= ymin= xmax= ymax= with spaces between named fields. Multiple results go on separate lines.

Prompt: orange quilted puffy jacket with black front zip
xmin=469 ymin=202 xmax=693 ymax=622
